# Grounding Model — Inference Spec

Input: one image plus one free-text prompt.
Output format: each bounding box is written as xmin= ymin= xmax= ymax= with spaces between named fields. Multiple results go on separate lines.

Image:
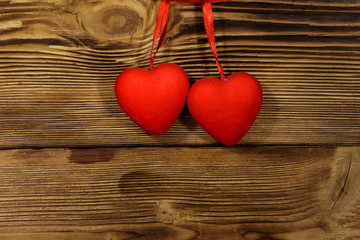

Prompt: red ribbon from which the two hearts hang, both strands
xmin=150 ymin=0 xmax=228 ymax=80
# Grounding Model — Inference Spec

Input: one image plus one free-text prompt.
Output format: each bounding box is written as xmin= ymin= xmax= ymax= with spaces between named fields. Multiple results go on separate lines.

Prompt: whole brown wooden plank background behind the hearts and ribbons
xmin=0 ymin=0 xmax=360 ymax=240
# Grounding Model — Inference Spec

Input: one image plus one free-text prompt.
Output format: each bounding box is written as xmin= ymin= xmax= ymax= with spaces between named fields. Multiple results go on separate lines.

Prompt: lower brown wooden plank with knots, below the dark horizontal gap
xmin=0 ymin=147 xmax=360 ymax=240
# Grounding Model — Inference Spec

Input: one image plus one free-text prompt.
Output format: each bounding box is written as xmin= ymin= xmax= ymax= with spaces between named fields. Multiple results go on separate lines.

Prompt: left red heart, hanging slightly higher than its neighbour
xmin=115 ymin=63 xmax=189 ymax=136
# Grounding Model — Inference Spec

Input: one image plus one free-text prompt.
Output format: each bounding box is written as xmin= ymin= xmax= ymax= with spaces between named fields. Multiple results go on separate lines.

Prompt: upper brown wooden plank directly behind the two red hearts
xmin=0 ymin=0 xmax=360 ymax=148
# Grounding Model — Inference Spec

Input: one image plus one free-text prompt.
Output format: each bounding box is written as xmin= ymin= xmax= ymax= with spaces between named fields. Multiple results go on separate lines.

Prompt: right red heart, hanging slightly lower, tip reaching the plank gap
xmin=187 ymin=73 xmax=262 ymax=146
